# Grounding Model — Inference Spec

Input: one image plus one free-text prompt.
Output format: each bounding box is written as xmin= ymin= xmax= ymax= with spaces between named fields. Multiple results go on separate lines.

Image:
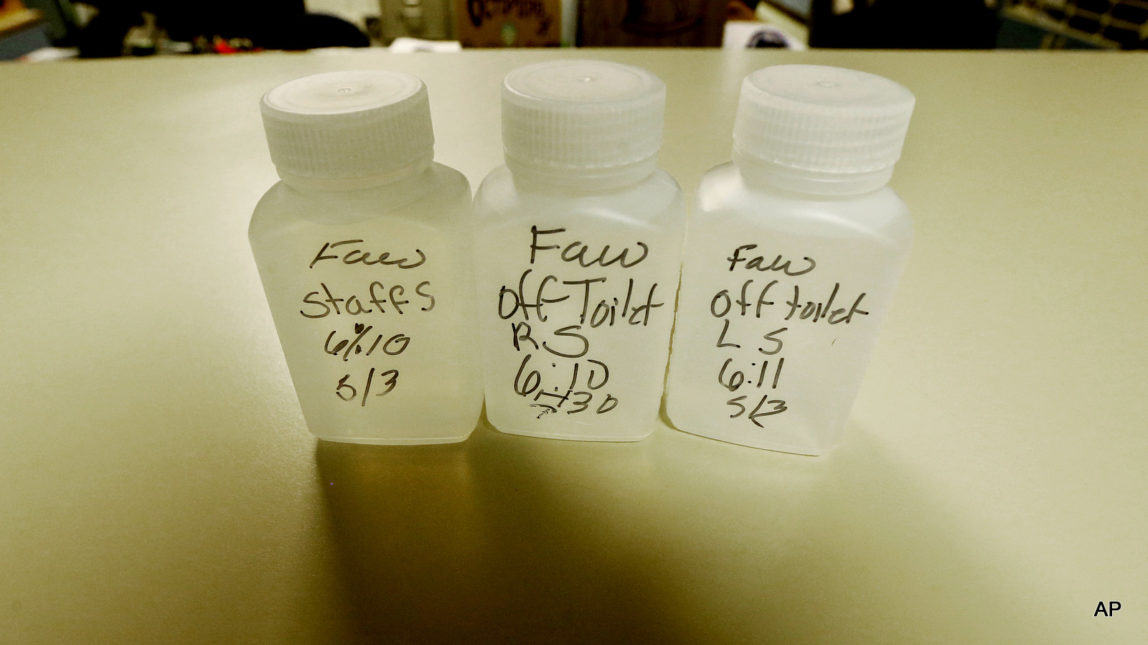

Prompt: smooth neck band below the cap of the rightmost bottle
xmin=734 ymin=147 xmax=893 ymax=197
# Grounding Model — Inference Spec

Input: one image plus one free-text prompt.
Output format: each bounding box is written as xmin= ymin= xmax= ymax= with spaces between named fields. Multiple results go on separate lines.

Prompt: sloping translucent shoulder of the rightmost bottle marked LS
xmin=691 ymin=163 xmax=913 ymax=246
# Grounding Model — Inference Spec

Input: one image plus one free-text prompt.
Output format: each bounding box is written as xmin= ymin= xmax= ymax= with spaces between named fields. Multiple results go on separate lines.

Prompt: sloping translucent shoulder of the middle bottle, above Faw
xmin=474 ymin=166 xmax=684 ymax=223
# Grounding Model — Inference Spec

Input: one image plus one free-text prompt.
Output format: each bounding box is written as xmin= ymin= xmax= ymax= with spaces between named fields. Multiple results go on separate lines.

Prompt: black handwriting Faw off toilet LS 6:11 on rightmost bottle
xmin=709 ymin=243 xmax=869 ymax=428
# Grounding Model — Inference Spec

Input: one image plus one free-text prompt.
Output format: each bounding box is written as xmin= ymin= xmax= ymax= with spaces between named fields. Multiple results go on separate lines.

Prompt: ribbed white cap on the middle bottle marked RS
xmin=502 ymin=61 xmax=666 ymax=170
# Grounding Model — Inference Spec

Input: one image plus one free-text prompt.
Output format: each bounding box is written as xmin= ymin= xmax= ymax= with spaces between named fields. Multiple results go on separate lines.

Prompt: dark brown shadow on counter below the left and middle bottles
xmin=316 ymin=422 xmax=688 ymax=643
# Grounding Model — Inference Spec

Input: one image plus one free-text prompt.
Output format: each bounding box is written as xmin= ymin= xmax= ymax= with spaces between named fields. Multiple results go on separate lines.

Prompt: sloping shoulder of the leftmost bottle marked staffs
xmin=249 ymin=163 xmax=471 ymax=236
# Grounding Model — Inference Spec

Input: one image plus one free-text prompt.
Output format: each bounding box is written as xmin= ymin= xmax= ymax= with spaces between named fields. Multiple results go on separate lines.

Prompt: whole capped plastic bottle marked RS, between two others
xmin=475 ymin=61 xmax=684 ymax=441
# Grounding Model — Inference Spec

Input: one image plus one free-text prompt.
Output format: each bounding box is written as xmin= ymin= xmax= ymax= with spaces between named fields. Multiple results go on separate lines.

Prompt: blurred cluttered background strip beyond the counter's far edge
xmin=0 ymin=0 xmax=1148 ymax=62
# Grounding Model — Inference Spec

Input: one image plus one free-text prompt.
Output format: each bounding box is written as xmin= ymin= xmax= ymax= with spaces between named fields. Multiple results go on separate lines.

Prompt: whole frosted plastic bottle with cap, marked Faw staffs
xmin=249 ymin=71 xmax=482 ymax=444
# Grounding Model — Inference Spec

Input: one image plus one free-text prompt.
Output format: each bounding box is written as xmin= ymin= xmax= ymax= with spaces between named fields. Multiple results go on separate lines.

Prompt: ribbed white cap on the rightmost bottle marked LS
xmin=734 ymin=65 xmax=914 ymax=179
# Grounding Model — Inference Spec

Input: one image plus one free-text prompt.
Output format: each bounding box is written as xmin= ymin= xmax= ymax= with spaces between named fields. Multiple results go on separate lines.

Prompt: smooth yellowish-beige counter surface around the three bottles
xmin=0 ymin=50 xmax=1148 ymax=644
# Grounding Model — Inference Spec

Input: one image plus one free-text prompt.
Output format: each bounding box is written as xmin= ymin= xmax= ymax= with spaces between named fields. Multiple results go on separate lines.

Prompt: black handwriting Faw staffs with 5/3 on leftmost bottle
xmin=298 ymin=239 xmax=435 ymax=407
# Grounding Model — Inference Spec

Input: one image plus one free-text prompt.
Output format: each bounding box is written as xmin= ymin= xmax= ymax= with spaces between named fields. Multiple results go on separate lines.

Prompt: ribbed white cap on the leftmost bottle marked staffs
xmin=261 ymin=70 xmax=434 ymax=180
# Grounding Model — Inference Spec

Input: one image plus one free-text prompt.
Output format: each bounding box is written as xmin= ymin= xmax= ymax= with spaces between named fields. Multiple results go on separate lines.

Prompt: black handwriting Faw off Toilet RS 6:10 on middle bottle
xmin=497 ymin=226 xmax=672 ymax=419
